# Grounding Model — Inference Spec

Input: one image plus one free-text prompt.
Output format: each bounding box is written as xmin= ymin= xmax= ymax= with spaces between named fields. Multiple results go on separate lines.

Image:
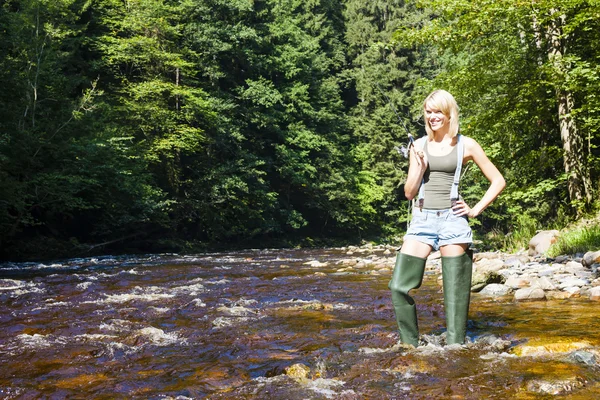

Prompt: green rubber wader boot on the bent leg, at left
xmin=388 ymin=253 xmax=427 ymax=347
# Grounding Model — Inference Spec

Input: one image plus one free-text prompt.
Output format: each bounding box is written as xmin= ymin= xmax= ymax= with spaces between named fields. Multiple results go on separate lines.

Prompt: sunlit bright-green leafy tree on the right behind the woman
xmin=398 ymin=0 xmax=598 ymax=234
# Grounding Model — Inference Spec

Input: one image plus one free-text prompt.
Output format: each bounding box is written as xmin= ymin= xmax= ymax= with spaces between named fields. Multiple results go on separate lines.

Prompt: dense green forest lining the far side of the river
xmin=0 ymin=0 xmax=600 ymax=260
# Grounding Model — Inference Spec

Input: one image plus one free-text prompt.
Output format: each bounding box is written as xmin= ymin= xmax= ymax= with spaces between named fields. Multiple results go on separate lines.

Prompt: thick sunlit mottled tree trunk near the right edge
xmin=548 ymin=10 xmax=592 ymax=211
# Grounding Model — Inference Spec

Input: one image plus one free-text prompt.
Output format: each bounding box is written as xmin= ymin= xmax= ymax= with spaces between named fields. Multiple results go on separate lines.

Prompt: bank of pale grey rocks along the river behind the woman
xmin=332 ymin=244 xmax=600 ymax=301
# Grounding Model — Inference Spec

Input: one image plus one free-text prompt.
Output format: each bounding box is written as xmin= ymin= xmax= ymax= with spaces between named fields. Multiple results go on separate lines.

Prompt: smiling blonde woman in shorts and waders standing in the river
xmin=389 ymin=90 xmax=506 ymax=347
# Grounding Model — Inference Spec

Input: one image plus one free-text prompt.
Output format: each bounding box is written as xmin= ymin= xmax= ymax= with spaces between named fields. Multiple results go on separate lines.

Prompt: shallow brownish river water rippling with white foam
xmin=0 ymin=249 xmax=600 ymax=399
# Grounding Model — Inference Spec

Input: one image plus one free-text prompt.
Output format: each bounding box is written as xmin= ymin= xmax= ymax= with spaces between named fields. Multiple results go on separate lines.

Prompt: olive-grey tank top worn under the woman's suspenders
xmin=423 ymin=142 xmax=458 ymax=210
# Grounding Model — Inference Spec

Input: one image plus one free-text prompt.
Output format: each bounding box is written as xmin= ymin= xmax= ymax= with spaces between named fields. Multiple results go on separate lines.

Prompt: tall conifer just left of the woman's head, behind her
xmin=344 ymin=0 xmax=432 ymax=234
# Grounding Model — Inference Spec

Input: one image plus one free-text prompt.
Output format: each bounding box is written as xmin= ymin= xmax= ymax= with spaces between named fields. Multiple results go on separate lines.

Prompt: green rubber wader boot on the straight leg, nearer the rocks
xmin=442 ymin=250 xmax=473 ymax=344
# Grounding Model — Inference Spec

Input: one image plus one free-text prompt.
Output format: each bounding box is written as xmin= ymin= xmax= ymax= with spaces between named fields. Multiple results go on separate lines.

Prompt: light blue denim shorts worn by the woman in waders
xmin=404 ymin=207 xmax=473 ymax=250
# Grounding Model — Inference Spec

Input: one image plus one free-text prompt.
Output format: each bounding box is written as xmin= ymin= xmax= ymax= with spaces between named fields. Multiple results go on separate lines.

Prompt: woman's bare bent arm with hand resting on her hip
xmin=453 ymin=138 xmax=506 ymax=217
